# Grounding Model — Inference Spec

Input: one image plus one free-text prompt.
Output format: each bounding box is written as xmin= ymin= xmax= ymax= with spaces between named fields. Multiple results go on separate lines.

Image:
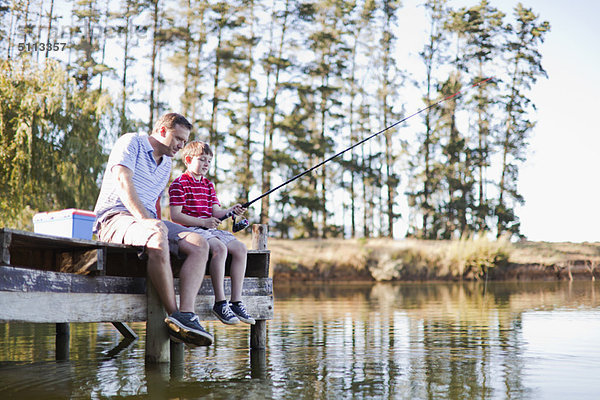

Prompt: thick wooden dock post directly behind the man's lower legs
xmin=146 ymin=275 xmax=170 ymax=364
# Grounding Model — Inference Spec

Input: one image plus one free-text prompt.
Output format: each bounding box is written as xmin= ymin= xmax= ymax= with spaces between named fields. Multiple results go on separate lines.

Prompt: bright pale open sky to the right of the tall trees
xmin=399 ymin=0 xmax=600 ymax=242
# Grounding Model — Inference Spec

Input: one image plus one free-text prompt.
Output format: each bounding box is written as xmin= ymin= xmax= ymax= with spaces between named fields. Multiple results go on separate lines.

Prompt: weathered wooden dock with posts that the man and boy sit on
xmin=0 ymin=225 xmax=273 ymax=363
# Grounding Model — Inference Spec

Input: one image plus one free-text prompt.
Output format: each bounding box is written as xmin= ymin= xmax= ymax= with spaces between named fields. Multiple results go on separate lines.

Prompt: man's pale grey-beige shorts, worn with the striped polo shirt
xmin=98 ymin=212 xmax=193 ymax=255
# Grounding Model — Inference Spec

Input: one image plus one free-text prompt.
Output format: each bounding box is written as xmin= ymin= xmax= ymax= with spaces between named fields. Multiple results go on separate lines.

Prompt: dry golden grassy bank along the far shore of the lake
xmin=243 ymin=236 xmax=600 ymax=281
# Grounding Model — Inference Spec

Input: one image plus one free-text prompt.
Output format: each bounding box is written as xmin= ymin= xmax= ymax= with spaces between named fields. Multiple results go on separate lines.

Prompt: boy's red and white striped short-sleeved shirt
xmin=169 ymin=172 xmax=221 ymax=218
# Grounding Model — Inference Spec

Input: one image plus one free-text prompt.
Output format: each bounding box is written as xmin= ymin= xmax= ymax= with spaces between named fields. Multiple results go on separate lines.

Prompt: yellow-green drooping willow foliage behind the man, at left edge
xmin=0 ymin=57 xmax=110 ymax=227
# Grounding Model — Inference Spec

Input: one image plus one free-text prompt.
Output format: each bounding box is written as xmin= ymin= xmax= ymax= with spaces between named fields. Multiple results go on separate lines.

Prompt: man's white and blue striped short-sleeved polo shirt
xmin=94 ymin=133 xmax=172 ymax=231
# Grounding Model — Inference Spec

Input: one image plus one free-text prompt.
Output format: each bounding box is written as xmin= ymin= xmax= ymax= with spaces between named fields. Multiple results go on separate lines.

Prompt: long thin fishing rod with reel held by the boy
xmin=220 ymin=77 xmax=493 ymax=232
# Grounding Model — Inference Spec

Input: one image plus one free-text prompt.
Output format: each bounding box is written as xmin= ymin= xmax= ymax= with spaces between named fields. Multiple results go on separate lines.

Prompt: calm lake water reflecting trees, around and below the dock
xmin=0 ymin=281 xmax=600 ymax=399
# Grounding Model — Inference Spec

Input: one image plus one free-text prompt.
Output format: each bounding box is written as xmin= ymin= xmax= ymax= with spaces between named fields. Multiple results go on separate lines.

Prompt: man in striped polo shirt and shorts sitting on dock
xmin=94 ymin=113 xmax=213 ymax=346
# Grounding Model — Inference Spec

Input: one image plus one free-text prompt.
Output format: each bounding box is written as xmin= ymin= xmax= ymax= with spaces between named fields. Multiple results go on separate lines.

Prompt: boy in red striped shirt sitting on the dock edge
xmin=169 ymin=142 xmax=255 ymax=325
